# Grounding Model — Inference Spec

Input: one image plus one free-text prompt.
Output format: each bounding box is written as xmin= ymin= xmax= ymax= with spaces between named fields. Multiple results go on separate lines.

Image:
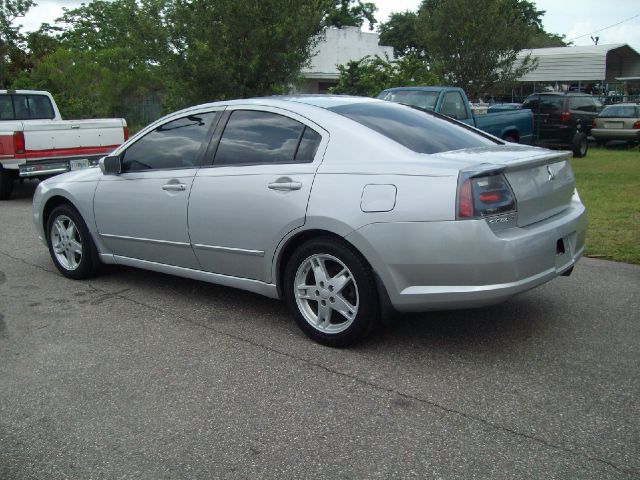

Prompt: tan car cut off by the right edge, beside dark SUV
xmin=591 ymin=103 xmax=640 ymax=145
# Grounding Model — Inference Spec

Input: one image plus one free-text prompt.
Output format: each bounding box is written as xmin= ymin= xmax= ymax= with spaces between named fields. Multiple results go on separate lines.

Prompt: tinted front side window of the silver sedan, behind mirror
xmin=122 ymin=112 xmax=216 ymax=172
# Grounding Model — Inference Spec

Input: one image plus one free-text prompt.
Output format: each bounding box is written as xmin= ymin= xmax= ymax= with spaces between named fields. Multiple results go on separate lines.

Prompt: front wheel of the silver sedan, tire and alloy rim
xmin=47 ymin=205 xmax=98 ymax=280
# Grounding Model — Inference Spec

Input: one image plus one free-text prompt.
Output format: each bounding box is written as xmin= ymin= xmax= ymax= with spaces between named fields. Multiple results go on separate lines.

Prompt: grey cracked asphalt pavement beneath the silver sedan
xmin=0 ymin=183 xmax=640 ymax=480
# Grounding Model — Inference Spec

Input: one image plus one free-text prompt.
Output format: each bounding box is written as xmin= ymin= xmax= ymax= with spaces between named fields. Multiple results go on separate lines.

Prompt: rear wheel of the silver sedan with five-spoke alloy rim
xmin=284 ymin=238 xmax=379 ymax=347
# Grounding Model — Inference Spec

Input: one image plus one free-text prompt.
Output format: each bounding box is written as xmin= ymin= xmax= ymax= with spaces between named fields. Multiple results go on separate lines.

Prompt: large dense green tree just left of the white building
xmin=162 ymin=0 xmax=331 ymax=106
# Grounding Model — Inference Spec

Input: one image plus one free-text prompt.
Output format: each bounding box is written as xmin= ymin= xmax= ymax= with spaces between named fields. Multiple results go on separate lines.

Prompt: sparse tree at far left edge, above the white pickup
xmin=0 ymin=0 xmax=35 ymax=89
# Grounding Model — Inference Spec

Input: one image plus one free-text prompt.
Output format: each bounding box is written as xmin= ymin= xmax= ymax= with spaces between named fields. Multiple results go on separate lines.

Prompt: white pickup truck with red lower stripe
xmin=0 ymin=90 xmax=129 ymax=200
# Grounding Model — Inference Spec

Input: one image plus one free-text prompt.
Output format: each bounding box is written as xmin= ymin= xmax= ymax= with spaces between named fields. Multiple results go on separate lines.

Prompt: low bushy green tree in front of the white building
xmin=331 ymin=54 xmax=438 ymax=97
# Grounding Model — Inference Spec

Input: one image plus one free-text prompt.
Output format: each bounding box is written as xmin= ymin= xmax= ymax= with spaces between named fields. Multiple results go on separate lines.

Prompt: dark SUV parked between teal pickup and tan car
xmin=522 ymin=93 xmax=602 ymax=157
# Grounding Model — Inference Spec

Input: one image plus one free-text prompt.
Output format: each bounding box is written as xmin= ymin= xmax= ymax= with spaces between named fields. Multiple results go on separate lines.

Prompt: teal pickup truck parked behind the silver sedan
xmin=378 ymin=87 xmax=534 ymax=144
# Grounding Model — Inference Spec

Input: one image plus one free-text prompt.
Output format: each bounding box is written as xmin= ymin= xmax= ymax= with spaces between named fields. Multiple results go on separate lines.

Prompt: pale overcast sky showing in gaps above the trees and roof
xmin=19 ymin=0 xmax=640 ymax=52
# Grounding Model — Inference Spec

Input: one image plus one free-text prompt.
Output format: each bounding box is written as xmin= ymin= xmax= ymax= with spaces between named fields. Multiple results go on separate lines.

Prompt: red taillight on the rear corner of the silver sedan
xmin=458 ymin=173 xmax=516 ymax=219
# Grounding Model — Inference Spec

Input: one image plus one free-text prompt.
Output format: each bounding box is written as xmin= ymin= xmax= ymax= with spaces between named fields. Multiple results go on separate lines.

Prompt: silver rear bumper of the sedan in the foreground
xmin=347 ymin=197 xmax=586 ymax=311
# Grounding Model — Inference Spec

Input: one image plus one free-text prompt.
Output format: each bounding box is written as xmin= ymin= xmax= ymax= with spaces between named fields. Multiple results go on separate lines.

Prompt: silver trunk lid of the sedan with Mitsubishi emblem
xmin=438 ymin=145 xmax=575 ymax=227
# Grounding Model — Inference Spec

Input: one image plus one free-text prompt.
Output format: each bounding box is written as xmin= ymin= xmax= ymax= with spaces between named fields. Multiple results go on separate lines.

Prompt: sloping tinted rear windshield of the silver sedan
xmin=329 ymin=102 xmax=500 ymax=153
